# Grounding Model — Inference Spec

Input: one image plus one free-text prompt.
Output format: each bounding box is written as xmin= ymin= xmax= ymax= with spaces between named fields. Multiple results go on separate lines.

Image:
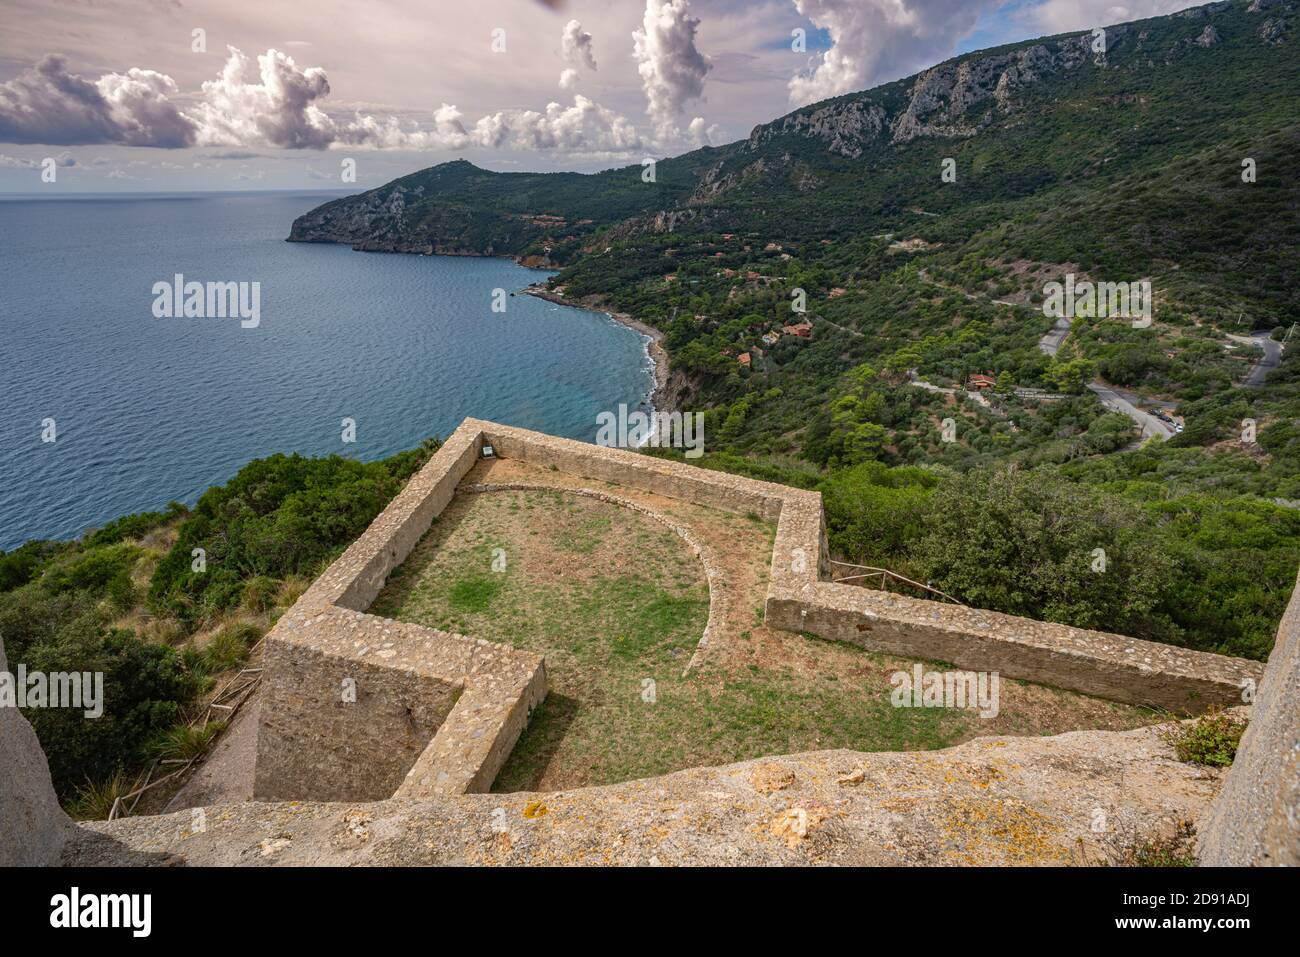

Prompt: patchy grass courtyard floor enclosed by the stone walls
xmin=371 ymin=490 xmax=1152 ymax=791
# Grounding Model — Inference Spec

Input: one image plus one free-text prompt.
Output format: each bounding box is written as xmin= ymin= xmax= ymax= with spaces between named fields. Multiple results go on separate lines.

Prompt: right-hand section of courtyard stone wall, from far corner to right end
xmin=478 ymin=419 xmax=1264 ymax=714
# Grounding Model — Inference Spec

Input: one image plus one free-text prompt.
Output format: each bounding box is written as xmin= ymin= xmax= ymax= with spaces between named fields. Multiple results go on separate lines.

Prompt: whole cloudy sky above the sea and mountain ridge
xmin=0 ymin=0 xmax=1196 ymax=196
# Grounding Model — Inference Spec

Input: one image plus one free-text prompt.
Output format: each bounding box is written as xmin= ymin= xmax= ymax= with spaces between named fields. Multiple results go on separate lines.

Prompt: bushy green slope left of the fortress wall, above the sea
xmin=0 ymin=441 xmax=437 ymax=814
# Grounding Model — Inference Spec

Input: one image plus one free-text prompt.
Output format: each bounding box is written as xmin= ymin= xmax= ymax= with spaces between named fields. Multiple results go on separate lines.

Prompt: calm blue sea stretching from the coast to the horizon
xmin=0 ymin=192 xmax=654 ymax=550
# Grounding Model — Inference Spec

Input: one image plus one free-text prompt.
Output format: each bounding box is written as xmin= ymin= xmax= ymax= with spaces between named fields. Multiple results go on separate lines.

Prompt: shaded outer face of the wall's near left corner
xmin=254 ymin=640 xmax=460 ymax=801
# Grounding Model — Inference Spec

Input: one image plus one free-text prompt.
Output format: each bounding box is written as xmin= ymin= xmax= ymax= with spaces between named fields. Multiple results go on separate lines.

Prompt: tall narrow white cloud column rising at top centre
xmin=632 ymin=0 xmax=712 ymax=139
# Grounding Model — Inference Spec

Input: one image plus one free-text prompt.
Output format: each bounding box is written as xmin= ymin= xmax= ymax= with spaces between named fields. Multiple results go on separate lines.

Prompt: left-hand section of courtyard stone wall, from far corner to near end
xmin=254 ymin=428 xmax=546 ymax=801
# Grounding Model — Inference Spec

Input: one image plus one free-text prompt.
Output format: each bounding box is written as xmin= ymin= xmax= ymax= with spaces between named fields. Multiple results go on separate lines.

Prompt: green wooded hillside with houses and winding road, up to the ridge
xmin=279 ymin=0 xmax=1300 ymax=657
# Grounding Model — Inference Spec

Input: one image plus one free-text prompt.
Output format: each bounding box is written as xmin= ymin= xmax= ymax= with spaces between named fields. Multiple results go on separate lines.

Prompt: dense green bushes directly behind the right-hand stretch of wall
xmin=820 ymin=462 xmax=1300 ymax=659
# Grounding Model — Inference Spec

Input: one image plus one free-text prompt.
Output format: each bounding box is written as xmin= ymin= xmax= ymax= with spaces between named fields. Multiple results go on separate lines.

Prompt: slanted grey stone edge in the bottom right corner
xmin=1200 ymin=566 xmax=1300 ymax=867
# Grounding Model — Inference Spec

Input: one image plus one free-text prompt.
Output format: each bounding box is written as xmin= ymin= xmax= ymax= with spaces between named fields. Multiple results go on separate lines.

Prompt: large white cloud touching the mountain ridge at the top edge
xmin=789 ymin=0 xmax=1003 ymax=107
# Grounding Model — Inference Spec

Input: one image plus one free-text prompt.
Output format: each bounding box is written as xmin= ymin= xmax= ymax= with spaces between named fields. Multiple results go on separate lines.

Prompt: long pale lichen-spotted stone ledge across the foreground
xmin=65 ymin=728 xmax=1222 ymax=866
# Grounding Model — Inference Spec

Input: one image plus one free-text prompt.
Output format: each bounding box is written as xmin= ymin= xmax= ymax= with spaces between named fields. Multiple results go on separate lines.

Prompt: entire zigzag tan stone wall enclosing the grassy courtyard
xmin=256 ymin=419 xmax=1262 ymax=800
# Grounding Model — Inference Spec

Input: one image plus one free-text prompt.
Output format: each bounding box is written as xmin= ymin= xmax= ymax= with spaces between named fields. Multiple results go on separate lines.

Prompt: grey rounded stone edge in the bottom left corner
xmin=0 ymin=638 xmax=74 ymax=867
